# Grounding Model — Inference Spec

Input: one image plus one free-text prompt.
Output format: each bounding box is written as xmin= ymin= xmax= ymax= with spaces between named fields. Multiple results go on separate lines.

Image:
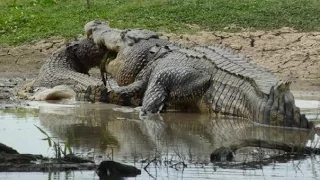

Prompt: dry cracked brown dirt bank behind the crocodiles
xmin=0 ymin=28 xmax=320 ymax=92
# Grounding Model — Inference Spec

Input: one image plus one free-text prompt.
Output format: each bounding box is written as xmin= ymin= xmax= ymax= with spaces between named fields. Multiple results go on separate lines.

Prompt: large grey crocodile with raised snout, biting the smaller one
xmin=79 ymin=20 xmax=312 ymax=128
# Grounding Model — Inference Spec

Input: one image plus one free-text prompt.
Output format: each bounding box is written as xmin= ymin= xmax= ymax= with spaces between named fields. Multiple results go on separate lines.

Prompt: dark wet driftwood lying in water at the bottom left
xmin=0 ymin=143 xmax=141 ymax=179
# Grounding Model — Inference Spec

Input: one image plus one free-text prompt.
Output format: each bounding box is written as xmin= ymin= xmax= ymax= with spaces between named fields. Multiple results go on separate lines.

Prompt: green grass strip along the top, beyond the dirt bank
xmin=0 ymin=0 xmax=320 ymax=45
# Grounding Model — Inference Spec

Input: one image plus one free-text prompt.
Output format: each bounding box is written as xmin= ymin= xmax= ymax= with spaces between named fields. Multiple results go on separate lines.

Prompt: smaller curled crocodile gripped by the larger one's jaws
xmin=27 ymin=39 xmax=107 ymax=99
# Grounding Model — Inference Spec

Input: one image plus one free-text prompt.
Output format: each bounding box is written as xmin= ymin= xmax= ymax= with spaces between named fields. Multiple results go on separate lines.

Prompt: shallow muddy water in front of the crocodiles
xmin=0 ymin=100 xmax=320 ymax=180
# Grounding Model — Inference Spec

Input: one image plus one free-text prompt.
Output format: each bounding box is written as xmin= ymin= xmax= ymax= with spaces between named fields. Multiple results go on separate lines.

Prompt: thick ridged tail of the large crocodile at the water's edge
xmin=204 ymin=70 xmax=313 ymax=128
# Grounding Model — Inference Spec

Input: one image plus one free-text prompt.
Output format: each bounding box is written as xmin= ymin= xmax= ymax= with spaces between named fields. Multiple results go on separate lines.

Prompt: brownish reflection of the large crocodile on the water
xmin=39 ymin=104 xmax=315 ymax=164
